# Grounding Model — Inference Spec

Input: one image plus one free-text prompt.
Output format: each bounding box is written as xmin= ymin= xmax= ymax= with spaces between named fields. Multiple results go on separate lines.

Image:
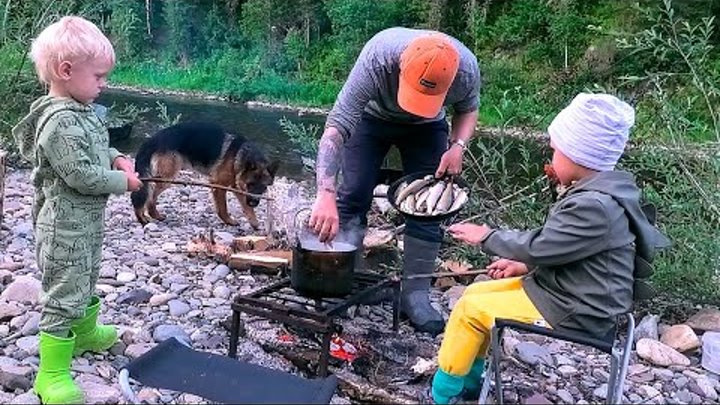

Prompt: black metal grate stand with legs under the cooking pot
xmin=228 ymin=271 xmax=400 ymax=377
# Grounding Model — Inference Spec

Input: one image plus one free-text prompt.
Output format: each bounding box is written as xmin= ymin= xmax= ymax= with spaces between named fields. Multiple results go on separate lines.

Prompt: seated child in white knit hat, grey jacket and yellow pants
xmin=432 ymin=93 xmax=664 ymax=403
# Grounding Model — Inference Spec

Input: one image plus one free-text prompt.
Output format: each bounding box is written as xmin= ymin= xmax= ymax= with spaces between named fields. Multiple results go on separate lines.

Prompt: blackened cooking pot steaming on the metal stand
xmin=290 ymin=235 xmax=357 ymax=298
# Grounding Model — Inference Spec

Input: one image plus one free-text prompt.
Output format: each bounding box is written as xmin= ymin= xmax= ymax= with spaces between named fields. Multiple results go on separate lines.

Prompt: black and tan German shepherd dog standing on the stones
xmin=130 ymin=122 xmax=278 ymax=229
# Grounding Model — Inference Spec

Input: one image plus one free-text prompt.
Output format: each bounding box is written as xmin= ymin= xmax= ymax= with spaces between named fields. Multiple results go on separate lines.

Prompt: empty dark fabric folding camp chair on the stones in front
xmin=120 ymin=337 xmax=337 ymax=404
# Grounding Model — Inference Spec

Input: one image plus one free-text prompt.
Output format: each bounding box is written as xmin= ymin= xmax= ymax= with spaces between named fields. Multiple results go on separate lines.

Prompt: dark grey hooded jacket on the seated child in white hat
xmin=482 ymin=171 xmax=669 ymax=337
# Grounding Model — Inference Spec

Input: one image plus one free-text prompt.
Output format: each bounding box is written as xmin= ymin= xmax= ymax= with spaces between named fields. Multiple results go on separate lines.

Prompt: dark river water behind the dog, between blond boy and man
xmin=96 ymin=90 xmax=325 ymax=180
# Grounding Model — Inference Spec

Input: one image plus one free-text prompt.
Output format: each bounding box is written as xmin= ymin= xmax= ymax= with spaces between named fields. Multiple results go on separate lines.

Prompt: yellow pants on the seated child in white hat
xmin=438 ymin=277 xmax=545 ymax=376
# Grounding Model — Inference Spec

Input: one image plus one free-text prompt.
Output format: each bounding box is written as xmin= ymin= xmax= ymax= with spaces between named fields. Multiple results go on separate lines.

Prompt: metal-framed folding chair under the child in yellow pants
xmin=478 ymin=313 xmax=635 ymax=404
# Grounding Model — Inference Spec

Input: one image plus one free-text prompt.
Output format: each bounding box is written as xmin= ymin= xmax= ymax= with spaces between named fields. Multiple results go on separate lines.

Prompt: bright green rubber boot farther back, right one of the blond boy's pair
xmin=70 ymin=296 xmax=117 ymax=356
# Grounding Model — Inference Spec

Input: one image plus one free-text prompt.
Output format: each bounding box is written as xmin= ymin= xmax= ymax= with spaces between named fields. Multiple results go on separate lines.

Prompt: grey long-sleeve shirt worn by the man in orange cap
xmin=325 ymin=28 xmax=480 ymax=139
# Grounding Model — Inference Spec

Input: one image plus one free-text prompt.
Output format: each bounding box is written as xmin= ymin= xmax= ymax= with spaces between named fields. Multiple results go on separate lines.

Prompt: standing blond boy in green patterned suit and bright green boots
xmin=13 ymin=17 xmax=141 ymax=403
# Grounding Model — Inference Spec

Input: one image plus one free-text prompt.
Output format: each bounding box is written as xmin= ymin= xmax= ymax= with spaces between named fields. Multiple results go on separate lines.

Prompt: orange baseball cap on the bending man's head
xmin=398 ymin=33 xmax=460 ymax=118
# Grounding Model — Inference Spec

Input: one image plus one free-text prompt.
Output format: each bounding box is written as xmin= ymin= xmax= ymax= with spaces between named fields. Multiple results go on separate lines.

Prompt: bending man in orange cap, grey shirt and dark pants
xmin=310 ymin=28 xmax=480 ymax=335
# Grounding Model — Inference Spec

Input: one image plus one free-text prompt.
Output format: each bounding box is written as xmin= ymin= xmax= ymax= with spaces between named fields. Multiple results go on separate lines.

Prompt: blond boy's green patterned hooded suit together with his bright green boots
xmin=13 ymin=96 xmax=127 ymax=403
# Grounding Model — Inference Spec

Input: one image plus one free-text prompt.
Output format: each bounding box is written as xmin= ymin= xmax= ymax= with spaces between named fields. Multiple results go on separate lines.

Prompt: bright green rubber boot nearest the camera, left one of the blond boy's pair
xmin=33 ymin=331 xmax=85 ymax=404
